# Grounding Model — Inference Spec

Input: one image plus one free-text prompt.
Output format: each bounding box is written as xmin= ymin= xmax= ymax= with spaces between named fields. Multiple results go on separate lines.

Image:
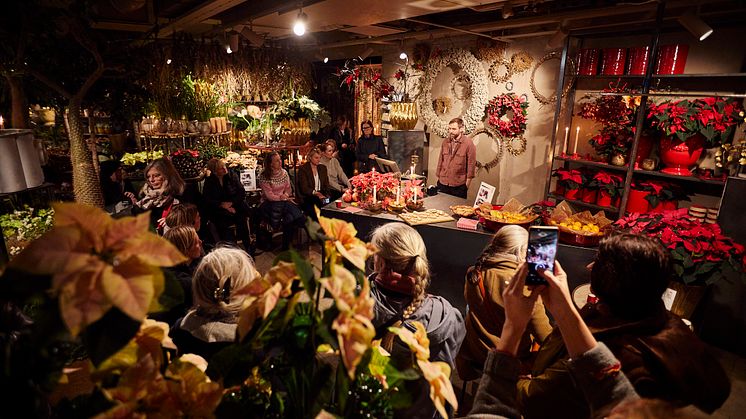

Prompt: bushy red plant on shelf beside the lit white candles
xmin=578 ymin=83 xmax=647 ymax=161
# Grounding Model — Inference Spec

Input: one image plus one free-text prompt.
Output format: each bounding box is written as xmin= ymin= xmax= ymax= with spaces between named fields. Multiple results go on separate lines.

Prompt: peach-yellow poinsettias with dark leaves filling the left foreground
xmin=0 ymin=203 xmax=457 ymax=418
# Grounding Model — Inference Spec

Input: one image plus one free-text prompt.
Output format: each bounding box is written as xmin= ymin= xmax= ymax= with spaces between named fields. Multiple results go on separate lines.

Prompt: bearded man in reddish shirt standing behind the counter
xmin=436 ymin=118 xmax=477 ymax=198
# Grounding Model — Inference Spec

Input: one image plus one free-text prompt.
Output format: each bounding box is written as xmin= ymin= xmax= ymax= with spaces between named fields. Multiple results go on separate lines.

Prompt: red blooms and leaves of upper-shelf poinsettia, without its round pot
xmin=648 ymin=97 xmax=744 ymax=147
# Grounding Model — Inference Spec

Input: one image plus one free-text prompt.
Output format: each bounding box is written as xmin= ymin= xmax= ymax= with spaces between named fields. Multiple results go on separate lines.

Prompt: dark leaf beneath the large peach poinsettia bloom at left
xmin=81 ymin=308 xmax=140 ymax=366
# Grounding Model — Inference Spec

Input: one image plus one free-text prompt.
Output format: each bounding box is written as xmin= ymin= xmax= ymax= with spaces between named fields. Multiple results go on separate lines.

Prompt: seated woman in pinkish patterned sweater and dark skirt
xmin=258 ymin=152 xmax=305 ymax=250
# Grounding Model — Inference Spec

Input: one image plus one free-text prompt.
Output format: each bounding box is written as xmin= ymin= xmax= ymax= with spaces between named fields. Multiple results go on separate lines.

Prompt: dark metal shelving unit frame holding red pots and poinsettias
xmin=545 ymin=2 xmax=746 ymax=217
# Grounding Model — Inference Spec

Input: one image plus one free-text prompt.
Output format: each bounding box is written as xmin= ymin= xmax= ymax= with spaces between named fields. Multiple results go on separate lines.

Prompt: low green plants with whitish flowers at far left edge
xmin=0 ymin=206 xmax=54 ymax=258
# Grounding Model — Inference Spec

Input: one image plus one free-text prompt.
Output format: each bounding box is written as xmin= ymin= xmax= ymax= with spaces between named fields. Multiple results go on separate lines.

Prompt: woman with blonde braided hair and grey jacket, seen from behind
xmin=371 ymin=223 xmax=465 ymax=417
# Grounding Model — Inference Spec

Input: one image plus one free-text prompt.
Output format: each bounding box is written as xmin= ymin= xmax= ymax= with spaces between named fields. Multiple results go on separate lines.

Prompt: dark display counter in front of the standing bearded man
xmin=321 ymin=194 xmax=596 ymax=313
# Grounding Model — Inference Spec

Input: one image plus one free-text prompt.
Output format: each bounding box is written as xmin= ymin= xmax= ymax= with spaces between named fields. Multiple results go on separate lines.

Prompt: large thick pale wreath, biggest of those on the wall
xmin=419 ymin=49 xmax=488 ymax=137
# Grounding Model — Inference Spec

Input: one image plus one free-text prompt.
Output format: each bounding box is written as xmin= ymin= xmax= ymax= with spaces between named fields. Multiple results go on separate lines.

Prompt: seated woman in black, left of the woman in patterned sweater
xmin=202 ymin=158 xmax=253 ymax=253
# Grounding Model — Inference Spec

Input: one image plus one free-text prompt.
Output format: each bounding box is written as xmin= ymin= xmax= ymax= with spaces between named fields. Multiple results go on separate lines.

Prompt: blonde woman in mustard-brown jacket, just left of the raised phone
xmin=456 ymin=225 xmax=552 ymax=381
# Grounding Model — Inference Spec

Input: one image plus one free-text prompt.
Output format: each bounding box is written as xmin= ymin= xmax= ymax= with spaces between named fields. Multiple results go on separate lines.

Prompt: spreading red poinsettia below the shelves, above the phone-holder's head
xmin=615 ymin=208 xmax=746 ymax=285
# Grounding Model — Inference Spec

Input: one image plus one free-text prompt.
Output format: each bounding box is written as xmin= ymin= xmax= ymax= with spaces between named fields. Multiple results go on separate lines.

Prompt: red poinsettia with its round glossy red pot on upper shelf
xmin=648 ymin=97 xmax=744 ymax=176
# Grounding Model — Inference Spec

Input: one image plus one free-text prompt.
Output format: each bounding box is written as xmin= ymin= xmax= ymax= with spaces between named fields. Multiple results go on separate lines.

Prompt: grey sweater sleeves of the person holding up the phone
xmin=467 ymin=343 xmax=639 ymax=419
